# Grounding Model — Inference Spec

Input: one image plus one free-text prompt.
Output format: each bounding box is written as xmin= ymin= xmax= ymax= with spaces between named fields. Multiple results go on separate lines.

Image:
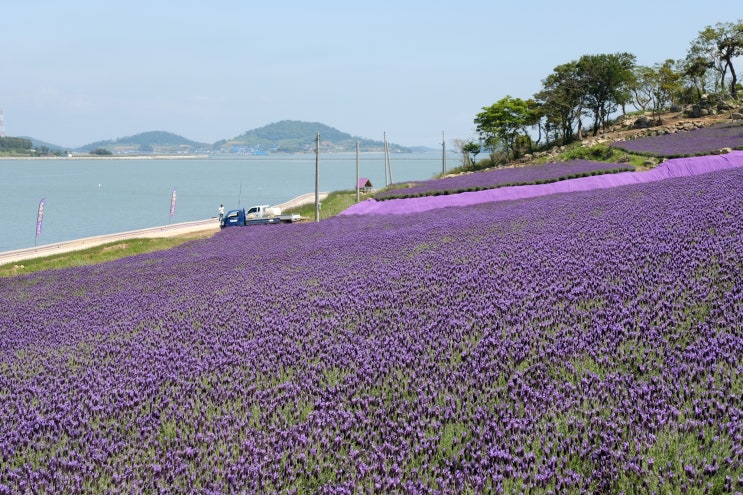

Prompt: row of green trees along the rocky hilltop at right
xmin=454 ymin=19 xmax=743 ymax=168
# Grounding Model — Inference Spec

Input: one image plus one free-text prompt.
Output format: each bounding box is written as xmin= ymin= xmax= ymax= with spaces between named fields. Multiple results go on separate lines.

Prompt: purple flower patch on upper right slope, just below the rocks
xmin=611 ymin=123 xmax=743 ymax=158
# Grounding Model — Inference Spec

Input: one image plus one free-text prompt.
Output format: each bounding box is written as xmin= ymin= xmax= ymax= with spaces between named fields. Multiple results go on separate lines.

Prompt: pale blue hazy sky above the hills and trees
xmin=0 ymin=0 xmax=743 ymax=147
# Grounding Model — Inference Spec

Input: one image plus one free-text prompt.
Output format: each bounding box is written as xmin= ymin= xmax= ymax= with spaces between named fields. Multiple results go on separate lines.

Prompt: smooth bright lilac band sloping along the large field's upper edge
xmin=341 ymin=151 xmax=743 ymax=215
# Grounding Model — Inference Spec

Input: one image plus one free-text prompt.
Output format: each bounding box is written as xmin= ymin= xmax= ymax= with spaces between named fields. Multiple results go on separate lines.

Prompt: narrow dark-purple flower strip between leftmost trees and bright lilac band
xmin=374 ymin=160 xmax=635 ymax=200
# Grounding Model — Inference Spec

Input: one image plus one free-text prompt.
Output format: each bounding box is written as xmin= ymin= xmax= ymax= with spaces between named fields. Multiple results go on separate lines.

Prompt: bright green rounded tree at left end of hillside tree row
xmin=475 ymin=96 xmax=534 ymax=158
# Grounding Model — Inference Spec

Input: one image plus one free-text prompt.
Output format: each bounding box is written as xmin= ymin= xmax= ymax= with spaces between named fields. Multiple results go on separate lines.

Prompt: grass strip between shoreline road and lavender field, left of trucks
xmin=0 ymin=232 xmax=212 ymax=277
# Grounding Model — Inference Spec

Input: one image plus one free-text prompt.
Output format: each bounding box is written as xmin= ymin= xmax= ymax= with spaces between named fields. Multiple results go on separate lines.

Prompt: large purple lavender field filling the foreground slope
xmin=0 ymin=169 xmax=743 ymax=494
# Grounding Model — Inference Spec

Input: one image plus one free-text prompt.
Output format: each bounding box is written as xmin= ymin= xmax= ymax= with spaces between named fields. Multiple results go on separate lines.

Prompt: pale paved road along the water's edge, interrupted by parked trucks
xmin=0 ymin=193 xmax=328 ymax=265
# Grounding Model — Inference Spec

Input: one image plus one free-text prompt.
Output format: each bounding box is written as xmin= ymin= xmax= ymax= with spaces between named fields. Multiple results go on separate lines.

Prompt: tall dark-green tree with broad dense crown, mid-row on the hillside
xmin=577 ymin=53 xmax=635 ymax=136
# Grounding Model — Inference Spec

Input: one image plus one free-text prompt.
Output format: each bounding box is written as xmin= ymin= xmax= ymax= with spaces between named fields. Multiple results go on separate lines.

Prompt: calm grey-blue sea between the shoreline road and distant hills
xmin=0 ymin=153 xmax=460 ymax=252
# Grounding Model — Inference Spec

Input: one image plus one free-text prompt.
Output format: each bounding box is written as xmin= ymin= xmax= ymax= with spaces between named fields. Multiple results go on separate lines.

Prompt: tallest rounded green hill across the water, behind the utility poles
xmin=214 ymin=120 xmax=410 ymax=152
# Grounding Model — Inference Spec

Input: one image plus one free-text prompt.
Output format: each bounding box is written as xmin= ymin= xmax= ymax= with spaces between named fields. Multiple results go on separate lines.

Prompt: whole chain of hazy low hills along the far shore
xmin=0 ymin=120 xmax=422 ymax=157
